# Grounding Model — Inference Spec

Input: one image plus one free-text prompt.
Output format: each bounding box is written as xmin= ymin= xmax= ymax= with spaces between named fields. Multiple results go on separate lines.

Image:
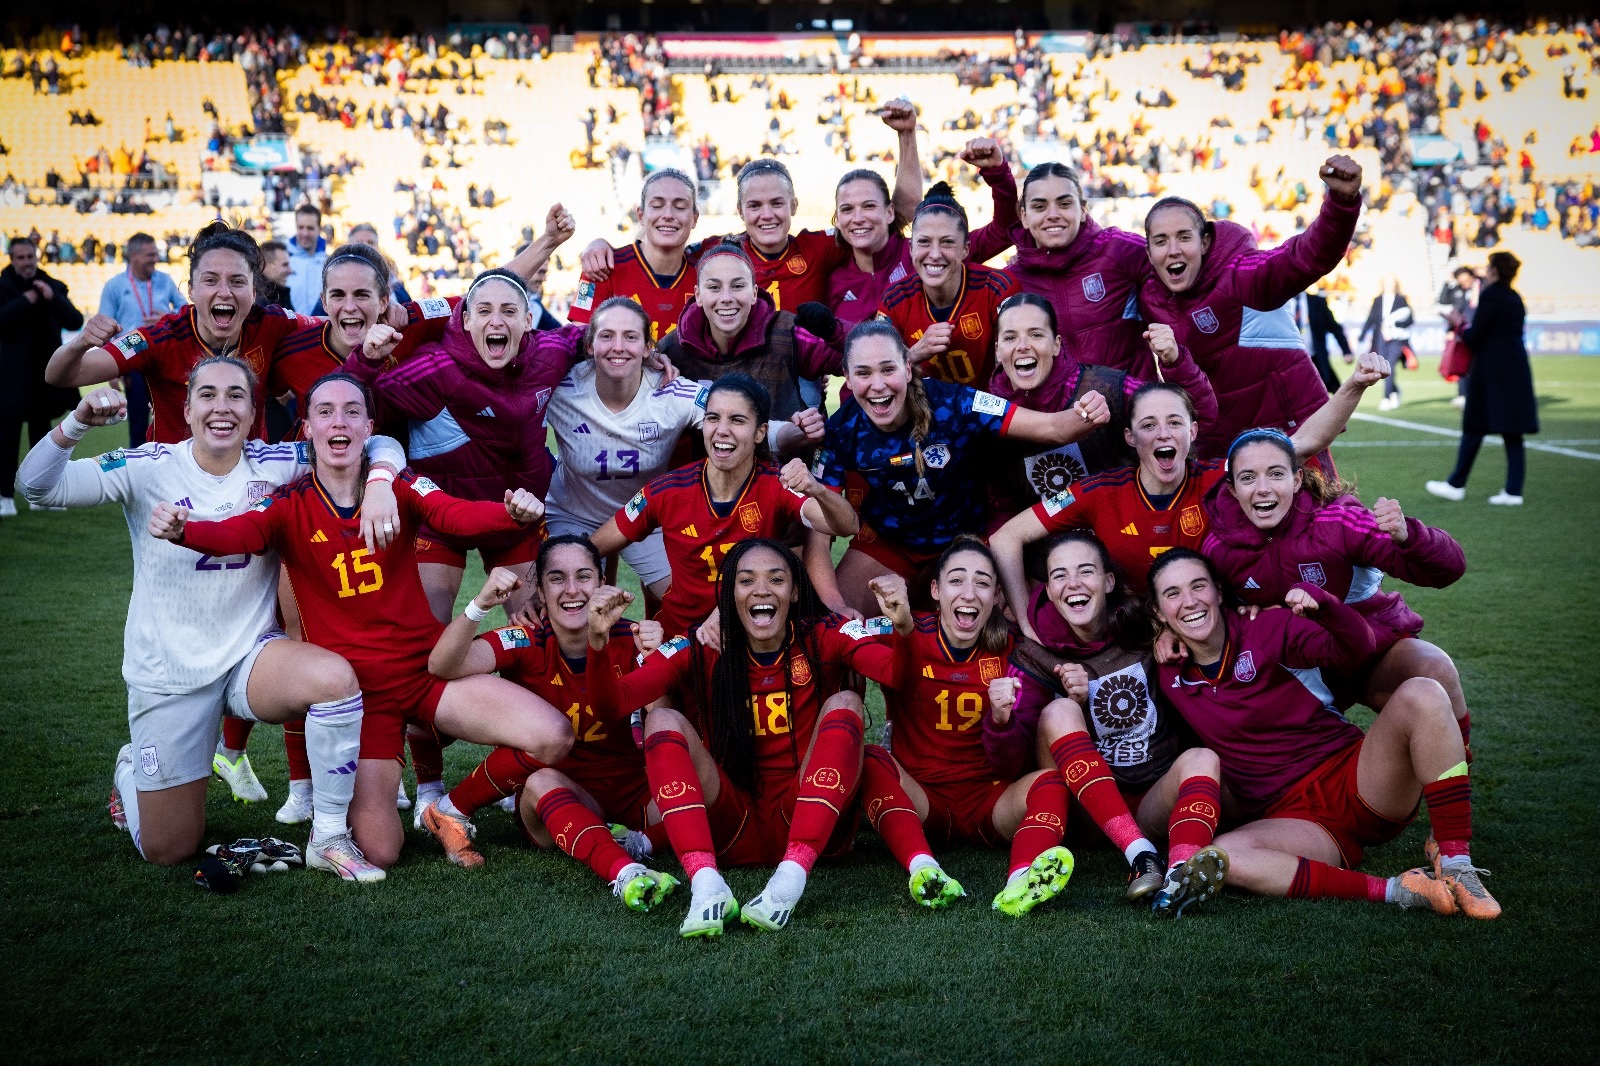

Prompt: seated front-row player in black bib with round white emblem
xmin=984 ymin=530 xmax=1227 ymax=916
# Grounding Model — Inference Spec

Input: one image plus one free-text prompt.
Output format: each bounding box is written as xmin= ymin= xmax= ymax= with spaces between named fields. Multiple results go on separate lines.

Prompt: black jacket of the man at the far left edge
xmin=0 ymin=266 xmax=83 ymax=418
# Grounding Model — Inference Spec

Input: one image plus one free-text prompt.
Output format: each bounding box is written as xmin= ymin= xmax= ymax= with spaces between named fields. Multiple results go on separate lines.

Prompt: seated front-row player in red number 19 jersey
xmin=861 ymin=544 xmax=1072 ymax=917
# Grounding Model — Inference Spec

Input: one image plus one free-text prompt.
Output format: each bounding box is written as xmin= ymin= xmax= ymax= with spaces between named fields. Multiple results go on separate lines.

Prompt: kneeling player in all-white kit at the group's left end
xmin=21 ymin=355 xmax=405 ymax=880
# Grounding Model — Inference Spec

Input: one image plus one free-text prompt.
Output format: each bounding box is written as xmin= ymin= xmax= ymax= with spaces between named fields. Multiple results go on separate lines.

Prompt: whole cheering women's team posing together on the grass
xmin=18 ymin=102 xmax=1499 ymax=936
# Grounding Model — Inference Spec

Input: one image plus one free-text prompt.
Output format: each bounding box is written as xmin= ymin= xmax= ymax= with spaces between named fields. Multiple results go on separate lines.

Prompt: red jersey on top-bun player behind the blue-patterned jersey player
xmin=878 ymin=266 xmax=1021 ymax=389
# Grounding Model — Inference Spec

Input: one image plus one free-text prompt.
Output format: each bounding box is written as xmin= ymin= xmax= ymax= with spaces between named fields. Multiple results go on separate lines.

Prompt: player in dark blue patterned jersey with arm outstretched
xmin=816 ymin=320 xmax=1109 ymax=615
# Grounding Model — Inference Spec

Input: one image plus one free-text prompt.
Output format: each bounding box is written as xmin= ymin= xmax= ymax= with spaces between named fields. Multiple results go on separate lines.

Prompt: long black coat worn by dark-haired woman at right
xmin=1461 ymin=282 xmax=1539 ymax=434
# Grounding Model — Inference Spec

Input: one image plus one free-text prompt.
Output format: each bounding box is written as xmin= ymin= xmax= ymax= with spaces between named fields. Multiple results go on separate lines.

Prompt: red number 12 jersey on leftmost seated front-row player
xmin=478 ymin=621 xmax=645 ymax=771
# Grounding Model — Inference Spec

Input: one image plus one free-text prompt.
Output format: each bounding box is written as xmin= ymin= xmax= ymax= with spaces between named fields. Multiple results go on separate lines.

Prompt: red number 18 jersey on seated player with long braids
xmin=589 ymin=615 xmax=894 ymax=792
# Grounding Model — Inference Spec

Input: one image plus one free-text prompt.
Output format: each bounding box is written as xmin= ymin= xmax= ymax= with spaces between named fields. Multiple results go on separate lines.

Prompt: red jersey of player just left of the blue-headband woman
xmin=1034 ymin=459 xmax=1226 ymax=595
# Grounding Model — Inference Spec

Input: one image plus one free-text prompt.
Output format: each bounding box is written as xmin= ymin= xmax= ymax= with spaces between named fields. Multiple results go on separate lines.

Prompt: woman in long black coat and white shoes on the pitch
xmin=1427 ymin=251 xmax=1539 ymax=506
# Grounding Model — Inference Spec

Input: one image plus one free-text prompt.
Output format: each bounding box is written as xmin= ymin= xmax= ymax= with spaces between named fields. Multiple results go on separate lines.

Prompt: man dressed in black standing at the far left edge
xmin=0 ymin=237 xmax=83 ymax=519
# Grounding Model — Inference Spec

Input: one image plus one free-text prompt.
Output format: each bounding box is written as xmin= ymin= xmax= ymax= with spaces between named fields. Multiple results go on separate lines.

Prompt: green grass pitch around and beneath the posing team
xmin=0 ymin=357 xmax=1600 ymax=1063
